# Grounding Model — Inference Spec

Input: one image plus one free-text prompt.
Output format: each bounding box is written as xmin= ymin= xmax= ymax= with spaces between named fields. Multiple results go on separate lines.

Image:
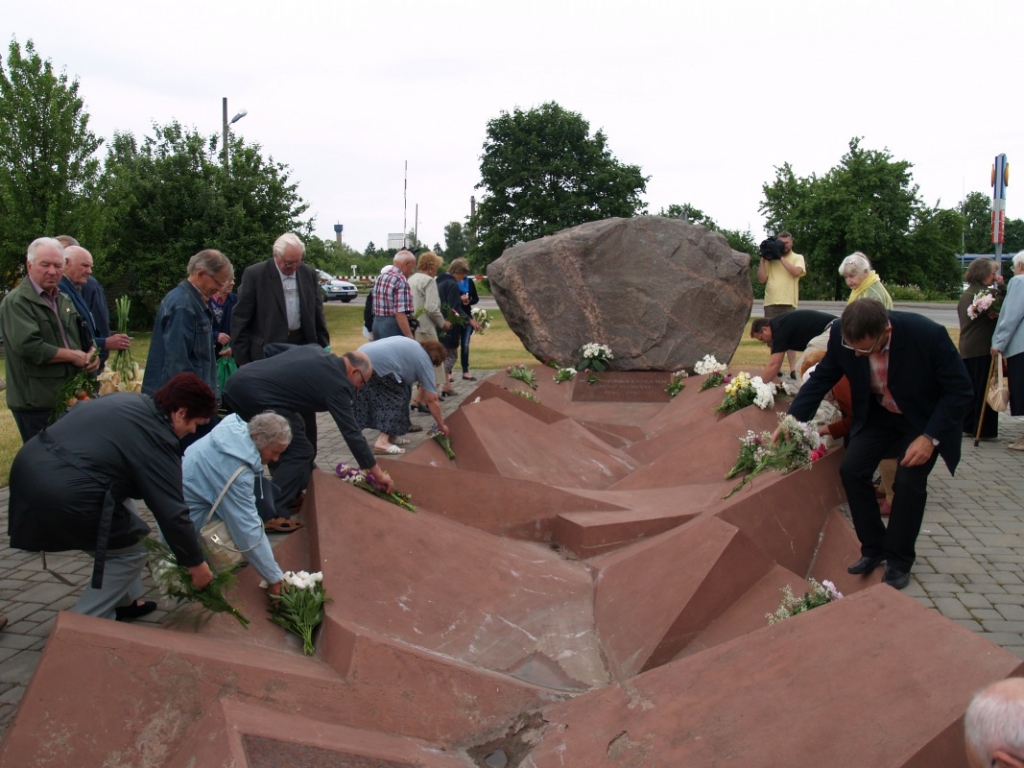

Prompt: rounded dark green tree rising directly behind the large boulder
xmin=470 ymin=101 xmax=648 ymax=266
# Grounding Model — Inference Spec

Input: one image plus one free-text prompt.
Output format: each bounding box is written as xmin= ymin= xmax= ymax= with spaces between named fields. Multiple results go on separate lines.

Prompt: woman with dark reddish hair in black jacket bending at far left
xmin=8 ymin=374 xmax=216 ymax=621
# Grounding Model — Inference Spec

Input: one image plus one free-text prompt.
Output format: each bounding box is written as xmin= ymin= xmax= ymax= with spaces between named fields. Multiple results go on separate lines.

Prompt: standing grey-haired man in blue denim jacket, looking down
xmin=142 ymin=249 xmax=234 ymax=444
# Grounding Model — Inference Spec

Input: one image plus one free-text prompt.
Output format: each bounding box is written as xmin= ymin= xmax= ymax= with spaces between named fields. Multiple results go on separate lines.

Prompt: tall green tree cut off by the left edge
xmin=0 ymin=40 xmax=102 ymax=288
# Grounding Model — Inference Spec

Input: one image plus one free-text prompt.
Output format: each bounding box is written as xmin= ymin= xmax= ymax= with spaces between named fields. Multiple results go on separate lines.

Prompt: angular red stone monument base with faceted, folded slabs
xmin=0 ymin=367 xmax=1022 ymax=768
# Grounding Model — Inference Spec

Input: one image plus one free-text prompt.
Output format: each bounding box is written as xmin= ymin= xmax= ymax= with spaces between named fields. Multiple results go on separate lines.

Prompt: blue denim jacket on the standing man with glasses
xmin=142 ymin=280 xmax=219 ymax=399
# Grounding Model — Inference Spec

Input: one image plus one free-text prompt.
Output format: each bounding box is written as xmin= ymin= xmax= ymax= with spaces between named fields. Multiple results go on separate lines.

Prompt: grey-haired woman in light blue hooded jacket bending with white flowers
xmin=182 ymin=412 xmax=292 ymax=594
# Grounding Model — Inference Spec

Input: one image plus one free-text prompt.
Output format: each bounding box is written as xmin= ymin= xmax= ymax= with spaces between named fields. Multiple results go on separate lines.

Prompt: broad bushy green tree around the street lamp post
xmin=94 ymin=122 xmax=309 ymax=319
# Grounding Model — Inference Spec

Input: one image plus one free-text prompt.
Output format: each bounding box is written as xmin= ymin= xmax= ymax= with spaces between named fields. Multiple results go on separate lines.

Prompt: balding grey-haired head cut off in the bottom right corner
xmin=964 ymin=677 xmax=1024 ymax=768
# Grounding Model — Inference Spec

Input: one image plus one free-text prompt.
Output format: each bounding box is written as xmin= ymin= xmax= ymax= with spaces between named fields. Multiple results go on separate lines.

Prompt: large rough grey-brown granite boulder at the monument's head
xmin=487 ymin=216 xmax=753 ymax=371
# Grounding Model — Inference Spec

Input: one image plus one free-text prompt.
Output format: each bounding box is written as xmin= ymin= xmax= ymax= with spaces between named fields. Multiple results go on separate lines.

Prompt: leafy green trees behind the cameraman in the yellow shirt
xmin=761 ymin=138 xmax=964 ymax=299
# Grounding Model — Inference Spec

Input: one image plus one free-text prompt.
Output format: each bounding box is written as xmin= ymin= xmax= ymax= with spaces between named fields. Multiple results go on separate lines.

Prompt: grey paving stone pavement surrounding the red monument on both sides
xmin=0 ymin=380 xmax=1024 ymax=735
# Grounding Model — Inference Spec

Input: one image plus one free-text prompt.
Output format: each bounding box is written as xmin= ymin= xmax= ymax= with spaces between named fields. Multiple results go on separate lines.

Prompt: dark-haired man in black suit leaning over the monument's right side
xmin=790 ymin=299 xmax=974 ymax=589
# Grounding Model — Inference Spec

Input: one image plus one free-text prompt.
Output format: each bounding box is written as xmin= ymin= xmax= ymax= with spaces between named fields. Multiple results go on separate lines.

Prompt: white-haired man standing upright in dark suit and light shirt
xmin=231 ymin=232 xmax=331 ymax=367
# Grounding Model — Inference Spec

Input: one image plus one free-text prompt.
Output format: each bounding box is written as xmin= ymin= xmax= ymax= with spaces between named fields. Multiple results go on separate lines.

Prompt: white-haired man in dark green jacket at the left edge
xmin=0 ymin=238 xmax=99 ymax=442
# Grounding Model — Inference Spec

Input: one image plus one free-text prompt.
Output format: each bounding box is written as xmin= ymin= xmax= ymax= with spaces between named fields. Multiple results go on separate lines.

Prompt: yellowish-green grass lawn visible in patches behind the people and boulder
xmin=0 ymin=303 xmax=959 ymax=486
